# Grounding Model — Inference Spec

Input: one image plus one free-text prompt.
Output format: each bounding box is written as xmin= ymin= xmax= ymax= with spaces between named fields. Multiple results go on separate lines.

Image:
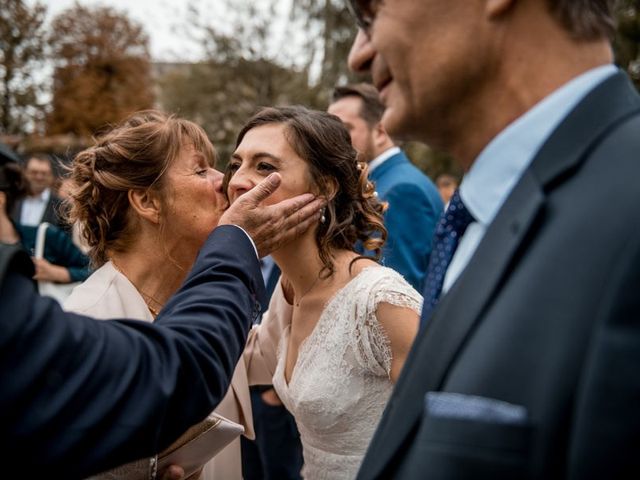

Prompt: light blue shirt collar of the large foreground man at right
xmin=460 ymin=65 xmax=617 ymax=225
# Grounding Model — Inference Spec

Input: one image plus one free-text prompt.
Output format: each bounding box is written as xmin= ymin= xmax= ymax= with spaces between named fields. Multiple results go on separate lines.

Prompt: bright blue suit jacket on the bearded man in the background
xmin=369 ymin=152 xmax=443 ymax=292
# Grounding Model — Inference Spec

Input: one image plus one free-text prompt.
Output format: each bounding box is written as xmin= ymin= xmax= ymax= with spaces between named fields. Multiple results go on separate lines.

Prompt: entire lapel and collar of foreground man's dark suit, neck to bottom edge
xmin=360 ymin=69 xmax=639 ymax=478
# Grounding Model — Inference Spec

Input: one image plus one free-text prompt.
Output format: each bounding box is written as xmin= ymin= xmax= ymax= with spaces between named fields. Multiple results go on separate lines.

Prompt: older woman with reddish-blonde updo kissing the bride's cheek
xmin=65 ymin=112 xmax=253 ymax=479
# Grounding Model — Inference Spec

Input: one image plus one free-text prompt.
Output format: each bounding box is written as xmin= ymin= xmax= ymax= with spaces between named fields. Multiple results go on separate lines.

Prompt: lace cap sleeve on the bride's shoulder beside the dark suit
xmin=353 ymin=267 xmax=422 ymax=377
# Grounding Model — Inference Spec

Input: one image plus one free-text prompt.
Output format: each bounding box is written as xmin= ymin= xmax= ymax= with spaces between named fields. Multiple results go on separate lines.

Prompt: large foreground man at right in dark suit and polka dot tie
xmin=349 ymin=0 xmax=640 ymax=479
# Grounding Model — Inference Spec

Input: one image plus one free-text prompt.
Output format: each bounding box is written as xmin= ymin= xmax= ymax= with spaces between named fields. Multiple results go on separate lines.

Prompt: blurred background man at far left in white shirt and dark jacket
xmin=12 ymin=154 xmax=68 ymax=230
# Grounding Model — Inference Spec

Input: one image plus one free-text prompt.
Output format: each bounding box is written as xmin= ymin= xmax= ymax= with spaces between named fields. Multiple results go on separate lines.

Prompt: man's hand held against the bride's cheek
xmin=218 ymin=173 xmax=325 ymax=257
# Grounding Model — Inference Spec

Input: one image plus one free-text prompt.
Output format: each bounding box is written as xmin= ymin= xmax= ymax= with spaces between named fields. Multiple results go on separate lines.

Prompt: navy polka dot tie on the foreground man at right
xmin=420 ymin=190 xmax=474 ymax=327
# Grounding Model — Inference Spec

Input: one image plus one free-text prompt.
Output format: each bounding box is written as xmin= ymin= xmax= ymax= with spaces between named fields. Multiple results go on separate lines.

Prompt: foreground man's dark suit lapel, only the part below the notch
xmin=365 ymin=173 xmax=544 ymax=478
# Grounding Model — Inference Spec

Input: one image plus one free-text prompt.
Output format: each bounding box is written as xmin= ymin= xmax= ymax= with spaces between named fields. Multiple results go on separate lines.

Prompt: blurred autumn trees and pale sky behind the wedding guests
xmin=0 ymin=0 xmax=640 ymax=178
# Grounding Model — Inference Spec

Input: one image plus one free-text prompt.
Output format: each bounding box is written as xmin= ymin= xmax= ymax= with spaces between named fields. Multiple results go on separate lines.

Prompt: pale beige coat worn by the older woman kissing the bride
xmin=64 ymin=262 xmax=252 ymax=480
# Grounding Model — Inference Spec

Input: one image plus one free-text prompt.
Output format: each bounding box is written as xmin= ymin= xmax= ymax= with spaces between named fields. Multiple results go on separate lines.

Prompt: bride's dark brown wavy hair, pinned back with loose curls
xmin=224 ymin=106 xmax=387 ymax=275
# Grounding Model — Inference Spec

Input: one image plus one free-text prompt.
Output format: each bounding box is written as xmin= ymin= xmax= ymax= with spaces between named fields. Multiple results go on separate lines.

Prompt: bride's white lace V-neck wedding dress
xmin=273 ymin=267 xmax=422 ymax=480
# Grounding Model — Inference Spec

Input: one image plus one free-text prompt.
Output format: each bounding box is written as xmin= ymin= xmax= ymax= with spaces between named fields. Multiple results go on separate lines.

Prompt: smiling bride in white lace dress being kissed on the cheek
xmin=225 ymin=107 xmax=422 ymax=479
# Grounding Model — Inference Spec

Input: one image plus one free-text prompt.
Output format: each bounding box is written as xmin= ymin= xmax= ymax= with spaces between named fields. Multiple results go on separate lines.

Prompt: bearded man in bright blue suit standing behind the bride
xmin=327 ymin=84 xmax=443 ymax=291
